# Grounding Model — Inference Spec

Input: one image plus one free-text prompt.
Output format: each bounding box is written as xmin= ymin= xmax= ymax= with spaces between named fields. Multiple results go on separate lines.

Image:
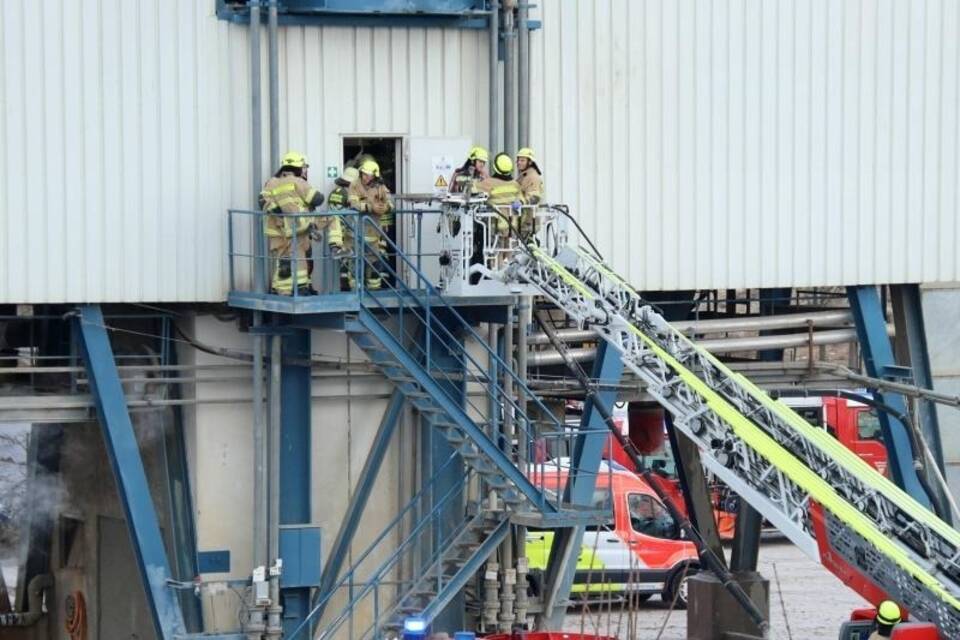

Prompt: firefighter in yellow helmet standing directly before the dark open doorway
xmin=350 ymin=160 xmax=394 ymax=289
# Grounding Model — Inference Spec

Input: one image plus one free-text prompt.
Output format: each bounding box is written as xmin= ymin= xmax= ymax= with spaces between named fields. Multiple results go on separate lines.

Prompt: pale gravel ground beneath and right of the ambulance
xmin=564 ymin=542 xmax=865 ymax=640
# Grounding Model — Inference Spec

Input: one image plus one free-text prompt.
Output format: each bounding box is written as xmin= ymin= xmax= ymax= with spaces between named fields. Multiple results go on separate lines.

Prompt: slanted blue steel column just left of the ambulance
xmin=541 ymin=342 xmax=623 ymax=629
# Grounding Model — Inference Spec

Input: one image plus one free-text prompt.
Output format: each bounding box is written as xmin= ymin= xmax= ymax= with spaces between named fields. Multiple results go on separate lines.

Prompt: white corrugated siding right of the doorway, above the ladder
xmin=532 ymin=0 xmax=960 ymax=290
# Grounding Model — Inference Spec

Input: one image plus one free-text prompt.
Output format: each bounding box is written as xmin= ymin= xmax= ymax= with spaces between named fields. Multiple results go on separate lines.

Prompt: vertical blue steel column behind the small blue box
xmin=273 ymin=329 xmax=311 ymax=634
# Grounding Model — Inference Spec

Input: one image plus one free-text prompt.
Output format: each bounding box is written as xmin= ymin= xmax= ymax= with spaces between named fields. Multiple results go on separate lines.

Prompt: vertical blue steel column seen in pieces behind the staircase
xmin=420 ymin=322 xmax=466 ymax=632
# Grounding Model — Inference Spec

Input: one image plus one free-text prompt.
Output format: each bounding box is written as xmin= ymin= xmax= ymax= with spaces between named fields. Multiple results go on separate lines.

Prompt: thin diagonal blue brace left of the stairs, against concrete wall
xmin=316 ymin=390 xmax=405 ymax=620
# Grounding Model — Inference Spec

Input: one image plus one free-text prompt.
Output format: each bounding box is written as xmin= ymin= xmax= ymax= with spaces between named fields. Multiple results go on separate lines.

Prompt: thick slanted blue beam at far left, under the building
xmin=76 ymin=305 xmax=185 ymax=640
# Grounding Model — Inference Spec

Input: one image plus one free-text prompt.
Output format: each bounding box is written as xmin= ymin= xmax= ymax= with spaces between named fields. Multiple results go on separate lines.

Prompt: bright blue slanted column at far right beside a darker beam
xmin=847 ymin=286 xmax=931 ymax=508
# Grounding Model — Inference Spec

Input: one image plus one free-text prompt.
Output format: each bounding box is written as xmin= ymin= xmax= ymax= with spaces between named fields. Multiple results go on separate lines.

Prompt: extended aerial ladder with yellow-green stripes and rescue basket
xmin=447 ymin=201 xmax=960 ymax=638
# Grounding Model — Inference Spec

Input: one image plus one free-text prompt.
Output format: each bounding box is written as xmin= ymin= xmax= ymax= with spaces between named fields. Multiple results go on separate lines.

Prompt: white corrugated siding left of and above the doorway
xmin=0 ymin=0 xmax=487 ymax=303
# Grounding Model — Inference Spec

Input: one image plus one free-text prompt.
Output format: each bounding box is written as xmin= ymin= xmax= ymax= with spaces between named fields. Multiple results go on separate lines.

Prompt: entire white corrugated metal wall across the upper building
xmin=0 ymin=0 xmax=960 ymax=302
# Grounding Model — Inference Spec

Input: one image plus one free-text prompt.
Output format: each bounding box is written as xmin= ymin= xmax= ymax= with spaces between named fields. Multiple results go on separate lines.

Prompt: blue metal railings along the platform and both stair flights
xmin=229 ymin=210 xmax=610 ymax=637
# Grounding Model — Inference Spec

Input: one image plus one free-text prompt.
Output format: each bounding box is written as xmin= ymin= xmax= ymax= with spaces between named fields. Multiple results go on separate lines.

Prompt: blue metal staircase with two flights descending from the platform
xmin=240 ymin=217 xmax=603 ymax=640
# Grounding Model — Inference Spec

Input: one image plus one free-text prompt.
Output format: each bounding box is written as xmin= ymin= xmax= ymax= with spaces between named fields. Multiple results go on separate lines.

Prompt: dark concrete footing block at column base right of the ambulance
xmin=687 ymin=572 xmax=770 ymax=640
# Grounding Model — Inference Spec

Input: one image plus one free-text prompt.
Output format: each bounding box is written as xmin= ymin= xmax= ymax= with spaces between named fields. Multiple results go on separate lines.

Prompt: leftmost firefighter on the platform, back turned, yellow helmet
xmin=260 ymin=151 xmax=343 ymax=296
